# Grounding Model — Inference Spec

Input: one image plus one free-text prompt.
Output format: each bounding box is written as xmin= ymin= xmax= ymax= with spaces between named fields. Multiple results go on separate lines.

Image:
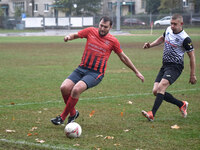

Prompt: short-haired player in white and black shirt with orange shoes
xmin=142 ymin=14 xmax=197 ymax=121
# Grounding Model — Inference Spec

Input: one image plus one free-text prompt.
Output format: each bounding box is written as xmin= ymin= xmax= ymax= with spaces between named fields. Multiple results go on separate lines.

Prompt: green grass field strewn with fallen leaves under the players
xmin=0 ymin=35 xmax=200 ymax=150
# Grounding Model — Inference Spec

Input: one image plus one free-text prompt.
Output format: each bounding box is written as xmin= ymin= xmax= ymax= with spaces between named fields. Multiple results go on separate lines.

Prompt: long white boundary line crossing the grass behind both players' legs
xmin=0 ymin=88 xmax=200 ymax=108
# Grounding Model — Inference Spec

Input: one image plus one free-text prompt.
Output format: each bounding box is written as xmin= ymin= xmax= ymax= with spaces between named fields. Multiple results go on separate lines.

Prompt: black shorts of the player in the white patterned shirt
xmin=155 ymin=64 xmax=183 ymax=84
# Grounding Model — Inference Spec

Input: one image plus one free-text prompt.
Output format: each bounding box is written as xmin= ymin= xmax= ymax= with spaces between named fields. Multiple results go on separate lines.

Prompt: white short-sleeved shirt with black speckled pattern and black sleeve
xmin=163 ymin=27 xmax=194 ymax=66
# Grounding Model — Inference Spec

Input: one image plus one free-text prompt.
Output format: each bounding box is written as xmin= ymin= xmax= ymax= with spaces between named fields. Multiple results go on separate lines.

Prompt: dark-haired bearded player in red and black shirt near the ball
xmin=51 ymin=17 xmax=144 ymax=125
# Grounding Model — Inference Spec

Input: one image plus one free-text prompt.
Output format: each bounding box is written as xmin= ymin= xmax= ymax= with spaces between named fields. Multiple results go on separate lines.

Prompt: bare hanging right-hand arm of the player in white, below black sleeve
xmin=187 ymin=51 xmax=197 ymax=84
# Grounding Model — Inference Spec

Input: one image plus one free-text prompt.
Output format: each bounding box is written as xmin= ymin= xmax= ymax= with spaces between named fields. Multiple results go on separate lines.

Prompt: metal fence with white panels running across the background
xmin=0 ymin=13 xmax=200 ymax=30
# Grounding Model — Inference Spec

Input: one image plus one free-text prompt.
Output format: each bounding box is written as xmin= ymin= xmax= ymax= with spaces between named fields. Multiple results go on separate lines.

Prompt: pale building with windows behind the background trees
xmin=0 ymin=0 xmax=197 ymax=17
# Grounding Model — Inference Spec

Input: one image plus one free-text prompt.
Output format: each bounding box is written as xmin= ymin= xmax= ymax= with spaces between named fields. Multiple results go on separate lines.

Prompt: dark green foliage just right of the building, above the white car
xmin=146 ymin=0 xmax=160 ymax=14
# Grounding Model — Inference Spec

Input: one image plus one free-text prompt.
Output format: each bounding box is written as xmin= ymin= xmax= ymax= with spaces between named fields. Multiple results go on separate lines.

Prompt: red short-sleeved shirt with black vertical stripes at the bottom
xmin=78 ymin=27 xmax=122 ymax=74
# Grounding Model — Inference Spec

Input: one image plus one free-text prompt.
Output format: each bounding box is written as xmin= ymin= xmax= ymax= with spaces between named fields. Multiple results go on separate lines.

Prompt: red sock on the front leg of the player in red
xmin=60 ymin=96 xmax=78 ymax=121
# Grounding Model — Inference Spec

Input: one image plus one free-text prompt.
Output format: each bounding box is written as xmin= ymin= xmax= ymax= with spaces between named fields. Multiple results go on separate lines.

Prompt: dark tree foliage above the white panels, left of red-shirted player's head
xmin=55 ymin=0 xmax=101 ymax=15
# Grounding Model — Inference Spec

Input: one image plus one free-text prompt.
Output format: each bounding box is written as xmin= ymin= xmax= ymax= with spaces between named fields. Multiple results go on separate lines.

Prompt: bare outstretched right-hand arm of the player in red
xmin=118 ymin=52 xmax=144 ymax=82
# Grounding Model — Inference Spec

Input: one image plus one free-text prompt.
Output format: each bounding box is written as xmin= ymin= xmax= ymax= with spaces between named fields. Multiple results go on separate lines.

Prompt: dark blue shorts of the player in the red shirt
xmin=67 ymin=67 xmax=104 ymax=89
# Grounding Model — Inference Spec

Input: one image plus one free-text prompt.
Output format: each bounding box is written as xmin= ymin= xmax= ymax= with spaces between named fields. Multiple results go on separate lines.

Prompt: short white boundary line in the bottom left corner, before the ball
xmin=0 ymin=139 xmax=77 ymax=150
